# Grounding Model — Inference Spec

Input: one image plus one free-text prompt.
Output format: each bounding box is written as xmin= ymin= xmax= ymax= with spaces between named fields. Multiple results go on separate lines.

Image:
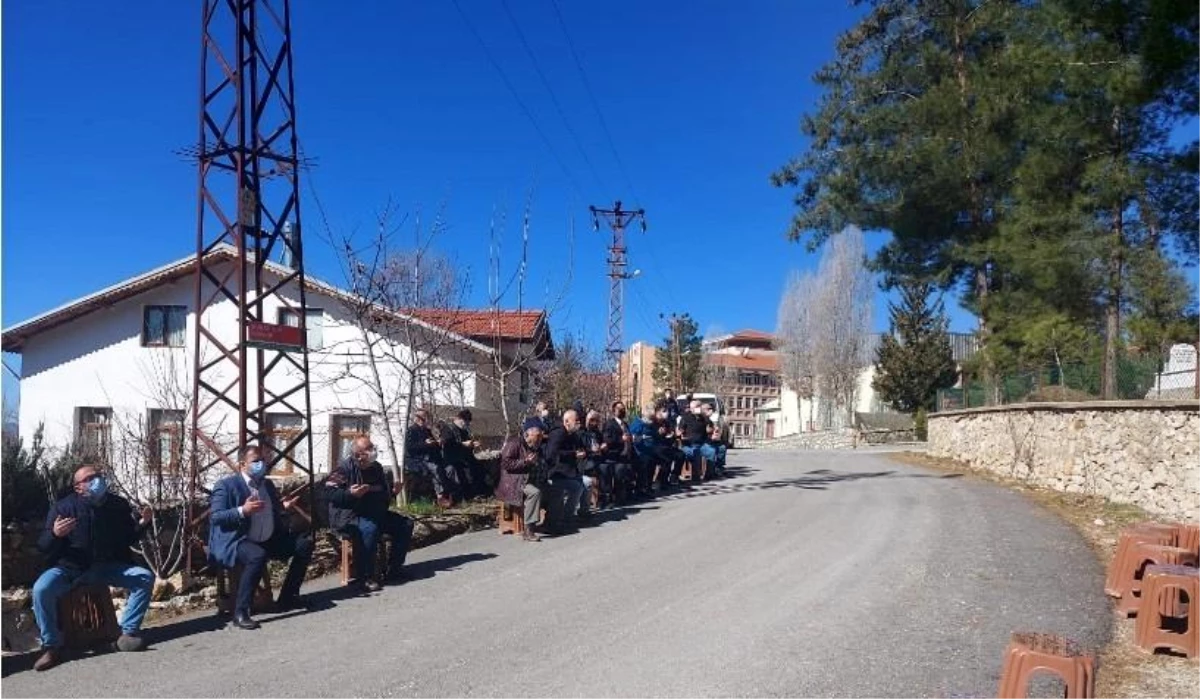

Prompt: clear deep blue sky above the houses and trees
xmin=2 ymin=0 xmax=1190 ymax=410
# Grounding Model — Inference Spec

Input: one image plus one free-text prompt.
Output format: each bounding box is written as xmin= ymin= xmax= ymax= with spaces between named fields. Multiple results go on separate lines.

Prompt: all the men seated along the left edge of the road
xmin=32 ymin=394 xmax=725 ymax=670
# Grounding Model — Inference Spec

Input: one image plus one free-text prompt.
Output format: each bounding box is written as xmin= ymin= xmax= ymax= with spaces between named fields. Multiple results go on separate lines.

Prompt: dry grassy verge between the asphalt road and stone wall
xmin=888 ymin=452 xmax=1200 ymax=699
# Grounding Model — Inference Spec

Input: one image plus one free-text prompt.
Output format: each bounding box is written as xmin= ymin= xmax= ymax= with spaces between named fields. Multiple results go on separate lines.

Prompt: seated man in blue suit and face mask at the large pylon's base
xmin=209 ymin=447 xmax=313 ymax=629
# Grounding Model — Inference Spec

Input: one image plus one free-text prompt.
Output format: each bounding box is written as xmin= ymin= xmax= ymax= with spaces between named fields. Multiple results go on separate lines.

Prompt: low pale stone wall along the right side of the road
xmin=929 ymin=401 xmax=1200 ymax=520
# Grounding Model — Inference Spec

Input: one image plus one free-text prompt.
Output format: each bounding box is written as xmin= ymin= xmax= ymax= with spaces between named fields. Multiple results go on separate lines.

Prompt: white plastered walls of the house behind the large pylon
xmin=19 ymin=263 xmax=492 ymax=487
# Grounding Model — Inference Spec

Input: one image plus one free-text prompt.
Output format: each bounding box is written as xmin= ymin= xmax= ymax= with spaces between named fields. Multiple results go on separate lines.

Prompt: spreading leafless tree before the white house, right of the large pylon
xmin=322 ymin=204 xmax=472 ymax=502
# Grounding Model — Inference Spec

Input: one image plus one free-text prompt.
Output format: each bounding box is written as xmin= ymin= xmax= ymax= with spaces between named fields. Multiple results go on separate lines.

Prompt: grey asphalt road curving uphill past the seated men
xmin=2 ymin=450 xmax=1110 ymax=699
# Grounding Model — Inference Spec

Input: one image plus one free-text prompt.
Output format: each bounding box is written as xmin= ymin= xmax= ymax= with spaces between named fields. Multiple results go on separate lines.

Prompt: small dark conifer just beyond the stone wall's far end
xmin=872 ymin=281 xmax=958 ymax=413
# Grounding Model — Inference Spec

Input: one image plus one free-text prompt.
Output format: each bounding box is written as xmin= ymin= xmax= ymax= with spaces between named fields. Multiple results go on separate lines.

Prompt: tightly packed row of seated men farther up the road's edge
xmin=496 ymin=393 xmax=726 ymax=542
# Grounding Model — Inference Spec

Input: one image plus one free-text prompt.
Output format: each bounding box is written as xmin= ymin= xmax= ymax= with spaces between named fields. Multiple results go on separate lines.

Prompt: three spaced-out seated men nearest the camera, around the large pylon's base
xmin=32 ymin=436 xmax=413 ymax=671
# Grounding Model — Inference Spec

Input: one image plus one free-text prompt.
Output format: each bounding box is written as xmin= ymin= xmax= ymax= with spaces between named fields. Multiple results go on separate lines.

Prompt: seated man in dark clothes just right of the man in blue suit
xmin=325 ymin=436 xmax=413 ymax=592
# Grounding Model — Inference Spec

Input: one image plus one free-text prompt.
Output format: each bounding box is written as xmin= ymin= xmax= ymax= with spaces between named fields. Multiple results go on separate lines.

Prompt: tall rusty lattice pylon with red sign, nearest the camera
xmin=190 ymin=0 xmax=313 ymax=542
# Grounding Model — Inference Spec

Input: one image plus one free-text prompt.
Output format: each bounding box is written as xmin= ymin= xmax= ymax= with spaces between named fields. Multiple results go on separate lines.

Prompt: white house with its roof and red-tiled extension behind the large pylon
xmin=2 ymin=247 xmax=553 ymax=485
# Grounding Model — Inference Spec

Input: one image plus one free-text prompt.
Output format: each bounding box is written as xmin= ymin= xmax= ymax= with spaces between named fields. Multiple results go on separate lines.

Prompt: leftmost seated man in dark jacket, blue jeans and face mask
xmin=34 ymin=466 xmax=154 ymax=671
